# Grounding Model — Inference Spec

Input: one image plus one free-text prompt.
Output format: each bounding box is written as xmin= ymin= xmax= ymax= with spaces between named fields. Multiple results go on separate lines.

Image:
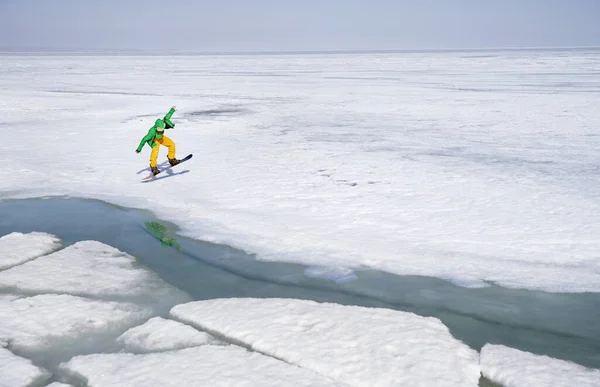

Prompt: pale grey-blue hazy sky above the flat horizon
xmin=0 ymin=0 xmax=600 ymax=52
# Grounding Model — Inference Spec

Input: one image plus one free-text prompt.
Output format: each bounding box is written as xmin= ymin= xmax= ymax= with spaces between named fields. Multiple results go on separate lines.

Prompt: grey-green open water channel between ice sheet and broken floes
xmin=0 ymin=198 xmax=600 ymax=368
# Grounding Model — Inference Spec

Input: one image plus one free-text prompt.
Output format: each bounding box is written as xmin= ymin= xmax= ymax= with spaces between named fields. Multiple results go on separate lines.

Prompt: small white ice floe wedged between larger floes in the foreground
xmin=117 ymin=317 xmax=218 ymax=353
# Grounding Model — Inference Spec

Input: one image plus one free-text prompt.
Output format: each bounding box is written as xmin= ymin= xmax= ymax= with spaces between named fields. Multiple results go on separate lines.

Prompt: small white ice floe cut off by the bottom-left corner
xmin=0 ymin=347 xmax=50 ymax=387
